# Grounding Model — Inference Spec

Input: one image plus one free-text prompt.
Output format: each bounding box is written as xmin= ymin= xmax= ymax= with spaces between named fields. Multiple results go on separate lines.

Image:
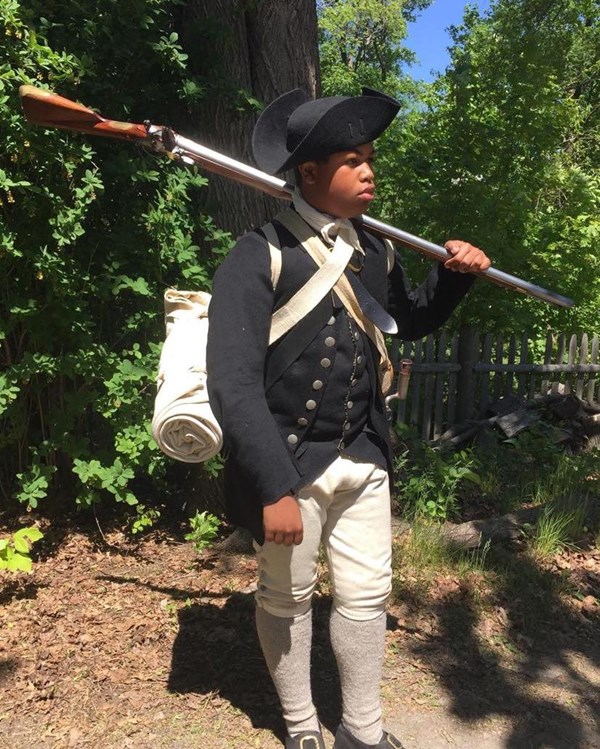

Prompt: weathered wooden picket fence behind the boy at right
xmin=390 ymin=328 xmax=600 ymax=440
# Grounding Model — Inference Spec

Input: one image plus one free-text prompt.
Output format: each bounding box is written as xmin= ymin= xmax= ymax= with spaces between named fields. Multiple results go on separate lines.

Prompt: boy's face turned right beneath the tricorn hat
xmin=298 ymin=143 xmax=375 ymax=218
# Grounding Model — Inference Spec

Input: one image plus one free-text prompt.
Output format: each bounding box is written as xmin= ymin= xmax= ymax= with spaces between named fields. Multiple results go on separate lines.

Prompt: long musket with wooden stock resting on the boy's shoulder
xmin=19 ymin=85 xmax=573 ymax=307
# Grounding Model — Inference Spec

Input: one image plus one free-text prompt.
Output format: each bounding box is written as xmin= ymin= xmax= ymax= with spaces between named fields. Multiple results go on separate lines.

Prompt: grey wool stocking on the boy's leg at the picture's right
xmin=329 ymin=608 xmax=386 ymax=745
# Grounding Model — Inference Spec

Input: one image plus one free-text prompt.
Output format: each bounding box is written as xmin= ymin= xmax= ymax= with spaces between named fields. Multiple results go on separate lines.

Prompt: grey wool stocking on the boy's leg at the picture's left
xmin=256 ymin=607 xmax=320 ymax=736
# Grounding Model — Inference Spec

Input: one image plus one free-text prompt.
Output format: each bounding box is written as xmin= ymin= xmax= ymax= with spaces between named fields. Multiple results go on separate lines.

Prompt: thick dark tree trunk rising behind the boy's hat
xmin=180 ymin=0 xmax=320 ymax=236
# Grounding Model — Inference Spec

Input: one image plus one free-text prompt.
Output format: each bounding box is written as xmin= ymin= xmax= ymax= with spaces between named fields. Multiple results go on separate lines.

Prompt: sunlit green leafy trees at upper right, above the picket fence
xmin=374 ymin=0 xmax=600 ymax=332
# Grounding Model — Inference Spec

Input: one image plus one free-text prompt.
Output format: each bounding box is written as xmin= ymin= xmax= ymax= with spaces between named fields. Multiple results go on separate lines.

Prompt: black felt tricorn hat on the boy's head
xmin=252 ymin=88 xmax=400 ymax=174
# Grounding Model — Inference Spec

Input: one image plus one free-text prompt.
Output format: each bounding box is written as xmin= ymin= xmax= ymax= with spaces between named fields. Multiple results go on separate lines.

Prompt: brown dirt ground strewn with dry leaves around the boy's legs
xmin=0 ymin=530 xmax=600 ymax=749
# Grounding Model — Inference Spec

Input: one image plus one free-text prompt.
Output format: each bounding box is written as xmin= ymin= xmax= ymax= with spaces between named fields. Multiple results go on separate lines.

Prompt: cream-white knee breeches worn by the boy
xmin=256 ymin=457 xmax=392 ymax=621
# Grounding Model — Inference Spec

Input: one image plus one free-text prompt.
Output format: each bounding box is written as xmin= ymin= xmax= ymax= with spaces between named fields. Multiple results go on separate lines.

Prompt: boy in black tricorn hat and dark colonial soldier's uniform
xmin=207 ymin=89 xmax=490 ymax=749
